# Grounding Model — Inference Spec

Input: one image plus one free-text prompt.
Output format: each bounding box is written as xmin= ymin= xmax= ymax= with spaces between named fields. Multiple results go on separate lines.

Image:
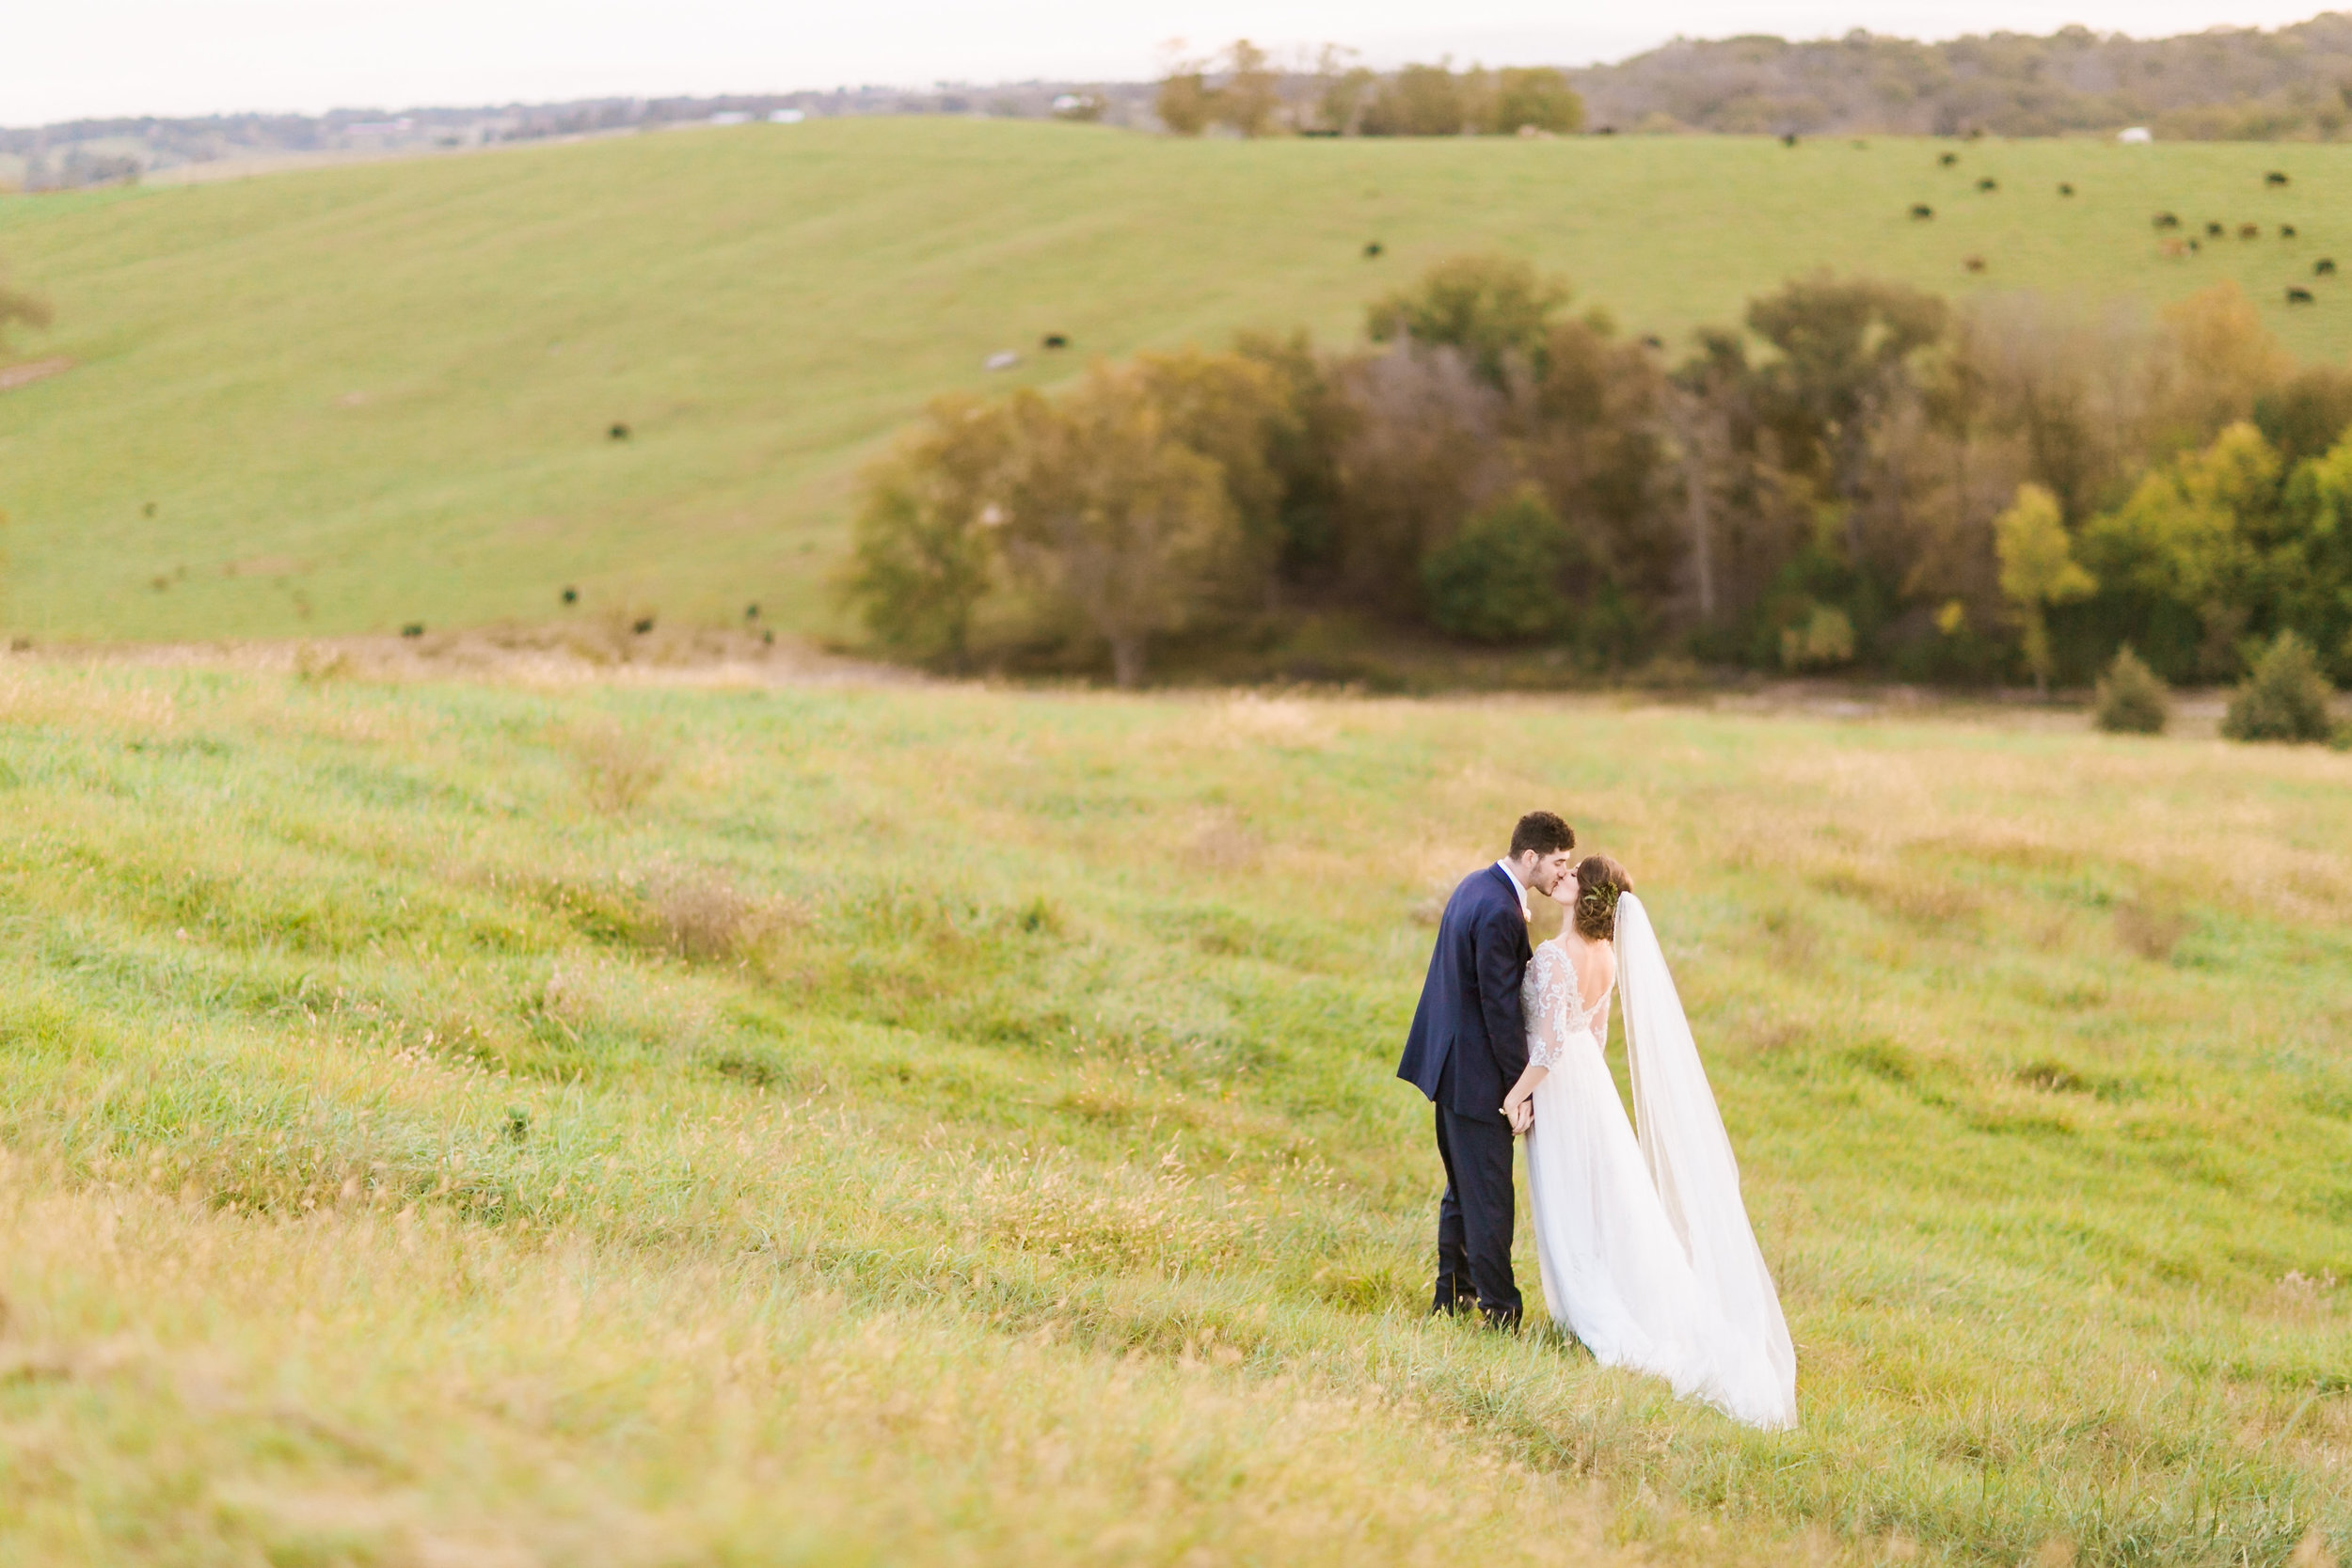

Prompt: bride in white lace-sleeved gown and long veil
xmin=1503 ymin=856 xmax=1797 ymax=1427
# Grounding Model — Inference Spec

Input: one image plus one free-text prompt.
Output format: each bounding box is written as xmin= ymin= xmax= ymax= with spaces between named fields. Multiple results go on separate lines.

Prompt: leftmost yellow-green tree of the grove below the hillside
xmin=842 ymin=397 xmax=1016 ymax=670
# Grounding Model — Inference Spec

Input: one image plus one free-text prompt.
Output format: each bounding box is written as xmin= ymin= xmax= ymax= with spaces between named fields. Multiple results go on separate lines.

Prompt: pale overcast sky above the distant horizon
xmin=13 ymin=0 xmax=2312 ymax=124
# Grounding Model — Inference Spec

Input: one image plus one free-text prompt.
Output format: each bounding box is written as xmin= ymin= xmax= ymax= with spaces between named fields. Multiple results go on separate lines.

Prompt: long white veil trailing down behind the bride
xmin=1618 ymin=894 xmax=1797 ymax=1427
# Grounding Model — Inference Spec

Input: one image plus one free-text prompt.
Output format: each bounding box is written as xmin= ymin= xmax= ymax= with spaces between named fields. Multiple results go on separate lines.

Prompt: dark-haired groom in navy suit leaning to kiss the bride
xmin=1397 ymin=811 xmax=1576 ymax=1328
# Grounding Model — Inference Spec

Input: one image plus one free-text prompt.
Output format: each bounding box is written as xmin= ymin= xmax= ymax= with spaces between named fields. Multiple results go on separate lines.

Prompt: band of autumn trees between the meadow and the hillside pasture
xmin=845 ymin=256 xmax=2352 ymax=719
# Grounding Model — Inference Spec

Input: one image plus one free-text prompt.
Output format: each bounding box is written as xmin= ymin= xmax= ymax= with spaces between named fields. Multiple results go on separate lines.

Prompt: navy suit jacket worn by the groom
xmin=1397 ymin=865 xmax=1534 ymax=1121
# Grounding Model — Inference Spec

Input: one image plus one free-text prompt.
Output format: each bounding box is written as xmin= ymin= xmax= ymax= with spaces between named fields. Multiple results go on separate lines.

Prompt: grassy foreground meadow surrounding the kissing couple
xmin=0 ymin=660 xmax=2352 ymax=1563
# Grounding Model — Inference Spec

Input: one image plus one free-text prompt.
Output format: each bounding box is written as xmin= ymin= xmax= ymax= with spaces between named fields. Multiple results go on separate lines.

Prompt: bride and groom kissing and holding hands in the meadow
xmin=1397 ymin=811 xmax=1797 ymax=1427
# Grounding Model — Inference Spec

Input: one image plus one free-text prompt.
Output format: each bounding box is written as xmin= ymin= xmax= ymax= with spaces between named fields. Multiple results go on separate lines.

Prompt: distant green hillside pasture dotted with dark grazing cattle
xmin=0 ymin=119 xmax=2352 ymax=640
